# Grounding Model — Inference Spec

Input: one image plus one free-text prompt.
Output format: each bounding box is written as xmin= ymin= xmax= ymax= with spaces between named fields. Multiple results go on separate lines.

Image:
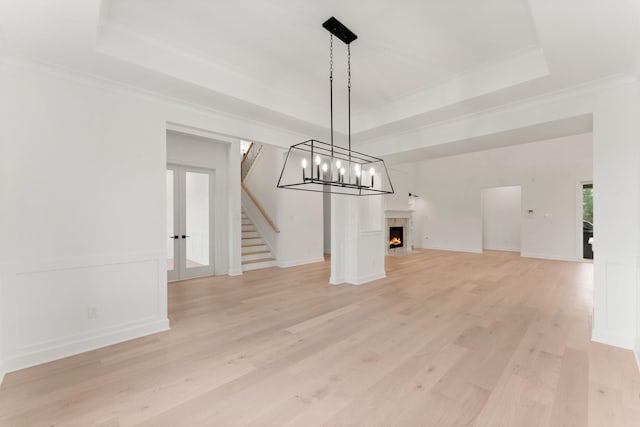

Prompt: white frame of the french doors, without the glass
xmin=167 ymin=163 xmax=215 ymax=282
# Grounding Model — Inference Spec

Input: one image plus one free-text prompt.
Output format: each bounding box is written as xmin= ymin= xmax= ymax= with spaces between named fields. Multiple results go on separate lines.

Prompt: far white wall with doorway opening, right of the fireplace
xmin=418 ymin=134 xmax=593 ymax=260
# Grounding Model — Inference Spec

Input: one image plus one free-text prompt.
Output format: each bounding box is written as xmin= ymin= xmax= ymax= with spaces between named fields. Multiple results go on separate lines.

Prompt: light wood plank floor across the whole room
xmin=0 ymin=251 xmax=640 ymax=427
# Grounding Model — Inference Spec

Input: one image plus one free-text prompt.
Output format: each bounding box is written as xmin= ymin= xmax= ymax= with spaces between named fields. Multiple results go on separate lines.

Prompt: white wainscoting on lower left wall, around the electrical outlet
xmin=0 ymin=256 xmax=168 ymax=371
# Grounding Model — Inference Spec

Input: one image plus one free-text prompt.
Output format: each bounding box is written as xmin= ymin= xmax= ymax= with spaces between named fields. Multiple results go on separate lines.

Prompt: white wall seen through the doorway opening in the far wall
xmin=482 ymin=186 xmax=523 ymax=252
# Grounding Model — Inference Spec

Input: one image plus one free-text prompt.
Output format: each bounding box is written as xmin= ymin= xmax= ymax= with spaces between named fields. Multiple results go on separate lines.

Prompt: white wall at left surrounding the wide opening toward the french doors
xmin=0 ymin=59 xmax=304 ymax=371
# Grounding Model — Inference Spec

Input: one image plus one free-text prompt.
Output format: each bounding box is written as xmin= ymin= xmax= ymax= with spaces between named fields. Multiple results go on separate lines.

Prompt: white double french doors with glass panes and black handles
xmin=166 ymin=165 xmax=215 ymax=281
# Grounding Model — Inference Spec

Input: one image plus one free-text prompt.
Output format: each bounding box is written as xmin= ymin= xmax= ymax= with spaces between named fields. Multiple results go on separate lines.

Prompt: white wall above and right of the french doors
xmin=167 ymin=132 xmax=232 ymax=275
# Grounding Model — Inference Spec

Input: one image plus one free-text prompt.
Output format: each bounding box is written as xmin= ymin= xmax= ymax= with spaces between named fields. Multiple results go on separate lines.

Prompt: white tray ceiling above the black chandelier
xmin=0 ymin=0 xmax=639 ymax=156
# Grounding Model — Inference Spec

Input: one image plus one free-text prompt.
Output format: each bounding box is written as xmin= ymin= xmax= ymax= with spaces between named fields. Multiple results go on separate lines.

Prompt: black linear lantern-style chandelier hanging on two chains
xmin=278 ymin=17 xmax=393 ymax=196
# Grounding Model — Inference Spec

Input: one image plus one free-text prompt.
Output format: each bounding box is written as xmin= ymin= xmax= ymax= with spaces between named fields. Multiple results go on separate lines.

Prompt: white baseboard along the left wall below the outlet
xmin=4 ymin=318 xmax=169 ymax=372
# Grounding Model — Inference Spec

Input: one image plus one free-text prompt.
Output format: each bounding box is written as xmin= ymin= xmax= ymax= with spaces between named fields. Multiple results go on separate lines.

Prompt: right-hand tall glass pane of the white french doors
xmin=185 ymin=172 xmax=210 ymax=268
